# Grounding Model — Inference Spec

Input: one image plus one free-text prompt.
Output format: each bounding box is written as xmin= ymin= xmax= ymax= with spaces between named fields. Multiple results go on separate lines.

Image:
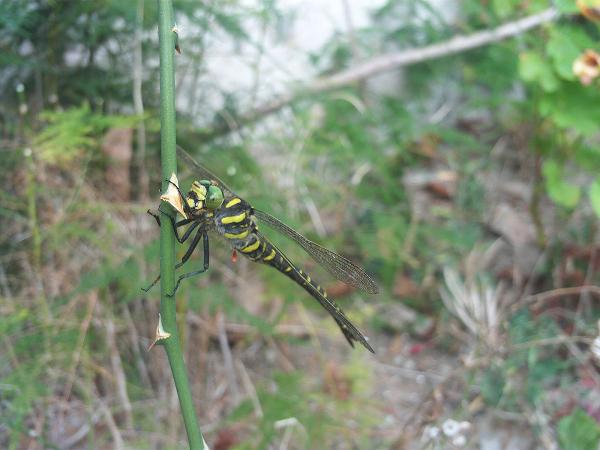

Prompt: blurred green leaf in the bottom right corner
xmin=558 ymin=408 xmax=600 ymax=450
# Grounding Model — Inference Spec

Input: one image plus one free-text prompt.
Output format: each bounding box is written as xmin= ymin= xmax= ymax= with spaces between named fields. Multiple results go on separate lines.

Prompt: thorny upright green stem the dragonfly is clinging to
xmin=158 ymin=0 xmax=207 ymax=450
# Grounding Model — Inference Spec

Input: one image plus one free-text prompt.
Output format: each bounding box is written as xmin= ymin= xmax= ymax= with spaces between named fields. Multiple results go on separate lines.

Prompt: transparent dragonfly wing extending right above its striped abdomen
xmin=254 ymin=209 xmax=379 ymax=294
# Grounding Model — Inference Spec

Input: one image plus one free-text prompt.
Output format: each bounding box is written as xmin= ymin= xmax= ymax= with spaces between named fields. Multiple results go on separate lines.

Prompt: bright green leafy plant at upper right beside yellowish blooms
xmin=519 ymin=7 xmax=600 ymax=215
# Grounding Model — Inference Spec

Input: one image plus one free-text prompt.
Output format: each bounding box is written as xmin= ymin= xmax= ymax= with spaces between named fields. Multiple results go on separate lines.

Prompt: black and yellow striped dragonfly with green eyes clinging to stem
xmin=144 ymin=146 xmax=378 ymax=353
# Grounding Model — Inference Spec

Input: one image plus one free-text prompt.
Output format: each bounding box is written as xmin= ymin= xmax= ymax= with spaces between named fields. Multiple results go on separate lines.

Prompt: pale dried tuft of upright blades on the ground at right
xmin=440 ymin=242 xmax=506 ymax=349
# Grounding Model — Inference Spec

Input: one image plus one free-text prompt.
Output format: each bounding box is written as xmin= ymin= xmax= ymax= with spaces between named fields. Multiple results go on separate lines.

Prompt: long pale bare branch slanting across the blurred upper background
xmin=200 ymin=8 xmax=559 ymax=139
